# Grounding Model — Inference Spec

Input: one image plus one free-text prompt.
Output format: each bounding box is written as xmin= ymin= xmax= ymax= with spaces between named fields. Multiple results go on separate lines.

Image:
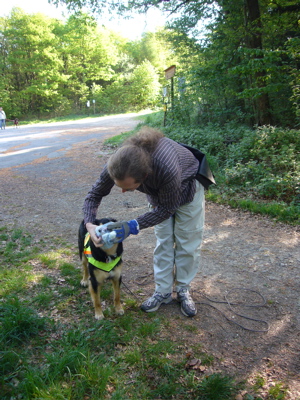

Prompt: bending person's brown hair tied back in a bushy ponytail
xmin=107 ymin=126 xmax=164 ymax=183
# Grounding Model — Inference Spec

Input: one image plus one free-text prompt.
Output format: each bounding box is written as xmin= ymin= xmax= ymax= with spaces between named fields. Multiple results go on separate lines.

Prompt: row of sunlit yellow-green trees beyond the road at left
xmin=0 ymin=8 xmax=171 ymax=119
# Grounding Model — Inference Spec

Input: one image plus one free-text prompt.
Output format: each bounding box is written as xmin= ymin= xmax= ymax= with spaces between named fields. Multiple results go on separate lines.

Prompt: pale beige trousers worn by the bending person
xmin=154 ymin=181 xmax=205 ymax=294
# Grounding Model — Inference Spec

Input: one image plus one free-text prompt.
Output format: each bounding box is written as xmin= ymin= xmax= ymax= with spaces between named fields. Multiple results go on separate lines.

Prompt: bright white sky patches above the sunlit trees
xmin=0 ymin=0 xmax=165 ymax=40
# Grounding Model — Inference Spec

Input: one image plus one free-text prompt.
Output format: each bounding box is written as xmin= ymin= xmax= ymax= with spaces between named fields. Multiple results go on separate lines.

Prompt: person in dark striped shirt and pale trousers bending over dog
xmin=83 ymin=127 xmax=204 ymax=317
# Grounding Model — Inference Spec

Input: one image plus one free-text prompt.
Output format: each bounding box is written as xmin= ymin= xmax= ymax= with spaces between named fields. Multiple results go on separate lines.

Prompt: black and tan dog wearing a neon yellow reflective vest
xmin=78 ymin=218 xmax=124 ymax=320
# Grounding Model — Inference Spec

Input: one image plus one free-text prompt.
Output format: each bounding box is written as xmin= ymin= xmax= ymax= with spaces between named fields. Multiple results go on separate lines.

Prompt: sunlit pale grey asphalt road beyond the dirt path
xmin=0 ymin=113 xmax=141 ymax=169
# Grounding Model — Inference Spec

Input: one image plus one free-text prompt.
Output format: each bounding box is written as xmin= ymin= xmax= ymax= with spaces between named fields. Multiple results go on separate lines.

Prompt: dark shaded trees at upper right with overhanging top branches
xmin=48 ymin=0 xmax=299 ymax=125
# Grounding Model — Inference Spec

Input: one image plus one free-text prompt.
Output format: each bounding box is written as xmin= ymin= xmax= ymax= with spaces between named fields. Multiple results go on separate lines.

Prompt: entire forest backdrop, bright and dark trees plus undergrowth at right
xmin=0 ymin=0 xmax=300 ymax=223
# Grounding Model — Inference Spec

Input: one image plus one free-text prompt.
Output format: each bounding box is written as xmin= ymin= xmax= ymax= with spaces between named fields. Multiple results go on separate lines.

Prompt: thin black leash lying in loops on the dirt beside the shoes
xmin=122 ymin=280 xmax=270 ymax=332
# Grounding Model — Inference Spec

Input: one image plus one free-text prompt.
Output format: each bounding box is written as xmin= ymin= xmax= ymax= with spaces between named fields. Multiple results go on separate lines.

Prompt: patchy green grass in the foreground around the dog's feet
xmin=0 ymin=228 xmax=285 ymax=400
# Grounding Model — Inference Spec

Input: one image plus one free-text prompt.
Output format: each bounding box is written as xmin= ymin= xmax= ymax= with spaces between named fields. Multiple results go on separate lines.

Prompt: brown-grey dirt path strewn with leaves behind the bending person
xmin=0 ymin=128 xmax=300 ymax=400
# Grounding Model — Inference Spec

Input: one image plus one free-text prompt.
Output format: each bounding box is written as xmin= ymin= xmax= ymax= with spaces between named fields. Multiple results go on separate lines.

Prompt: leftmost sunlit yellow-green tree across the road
xmin=1 ymin=9 xmax=63 ymax=116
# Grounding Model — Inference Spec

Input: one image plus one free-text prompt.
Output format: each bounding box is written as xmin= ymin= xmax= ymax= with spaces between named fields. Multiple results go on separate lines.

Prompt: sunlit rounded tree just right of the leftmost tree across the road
xmin=56 ymin=12 xmax=118 ymax=110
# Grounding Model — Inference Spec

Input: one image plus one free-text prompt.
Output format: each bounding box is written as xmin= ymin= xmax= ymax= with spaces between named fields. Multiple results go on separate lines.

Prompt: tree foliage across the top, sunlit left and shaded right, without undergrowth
xmin=0 ymin=0 xmax=300 ymax=128
